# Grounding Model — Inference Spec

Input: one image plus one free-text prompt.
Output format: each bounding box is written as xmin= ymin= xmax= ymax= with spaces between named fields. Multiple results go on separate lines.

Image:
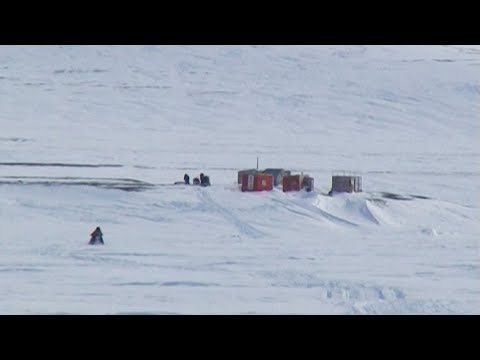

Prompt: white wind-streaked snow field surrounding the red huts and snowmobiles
xmin=0 ymin=46 xmax=480 ymax=314
